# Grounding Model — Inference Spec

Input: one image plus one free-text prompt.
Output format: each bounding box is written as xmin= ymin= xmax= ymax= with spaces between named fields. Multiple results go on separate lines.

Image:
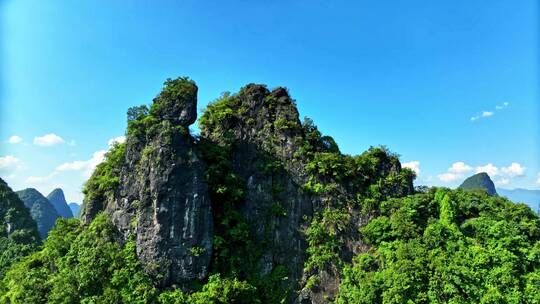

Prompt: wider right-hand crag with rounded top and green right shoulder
xmin=200 ymin=84 xmax=413 ymax=303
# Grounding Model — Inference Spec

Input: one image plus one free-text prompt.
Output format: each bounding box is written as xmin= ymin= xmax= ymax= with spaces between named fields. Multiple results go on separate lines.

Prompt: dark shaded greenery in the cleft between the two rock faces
xmin=198 ymin=138 xmax=289 ymax=303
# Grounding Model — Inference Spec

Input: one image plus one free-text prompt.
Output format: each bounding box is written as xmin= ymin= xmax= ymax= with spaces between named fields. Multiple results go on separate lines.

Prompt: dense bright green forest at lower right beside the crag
xmin=337 ymin=189 xmax=540 ymax=303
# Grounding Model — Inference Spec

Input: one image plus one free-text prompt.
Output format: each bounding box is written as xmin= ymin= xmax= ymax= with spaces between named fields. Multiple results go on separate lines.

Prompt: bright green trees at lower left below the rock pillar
xmin=0 ymin=214 xmax=260 ymax=304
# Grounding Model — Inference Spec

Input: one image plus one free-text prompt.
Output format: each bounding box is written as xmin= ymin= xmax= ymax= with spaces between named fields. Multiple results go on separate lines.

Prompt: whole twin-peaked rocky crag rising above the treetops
xmin=81 ymin=78 xmax=414 ymax=303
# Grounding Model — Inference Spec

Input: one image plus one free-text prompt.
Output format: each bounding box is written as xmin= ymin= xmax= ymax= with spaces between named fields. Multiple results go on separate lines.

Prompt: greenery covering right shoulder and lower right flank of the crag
xmin=303 ymin=143 xmax=415 ymax=284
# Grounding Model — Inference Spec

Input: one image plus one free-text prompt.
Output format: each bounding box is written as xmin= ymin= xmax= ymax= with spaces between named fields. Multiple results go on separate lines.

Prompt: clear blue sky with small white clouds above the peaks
xmin=0 ymin=0 xmax=540 ymax=202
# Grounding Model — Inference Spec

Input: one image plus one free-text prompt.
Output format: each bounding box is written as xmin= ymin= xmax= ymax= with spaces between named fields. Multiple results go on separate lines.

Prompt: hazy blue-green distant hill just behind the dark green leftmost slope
xmin=16 ymin=188 xmax=59 ymax=239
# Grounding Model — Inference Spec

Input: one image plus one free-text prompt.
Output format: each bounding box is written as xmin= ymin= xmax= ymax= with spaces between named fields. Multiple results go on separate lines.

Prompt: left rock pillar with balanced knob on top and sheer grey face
xmin=82 ymin=80 xmax=213 ymax=288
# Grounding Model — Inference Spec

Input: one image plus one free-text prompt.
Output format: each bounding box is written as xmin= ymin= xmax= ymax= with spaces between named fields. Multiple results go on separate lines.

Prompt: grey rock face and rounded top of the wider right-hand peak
xmin=202 ymin=84 xmax=320 ymax=288
